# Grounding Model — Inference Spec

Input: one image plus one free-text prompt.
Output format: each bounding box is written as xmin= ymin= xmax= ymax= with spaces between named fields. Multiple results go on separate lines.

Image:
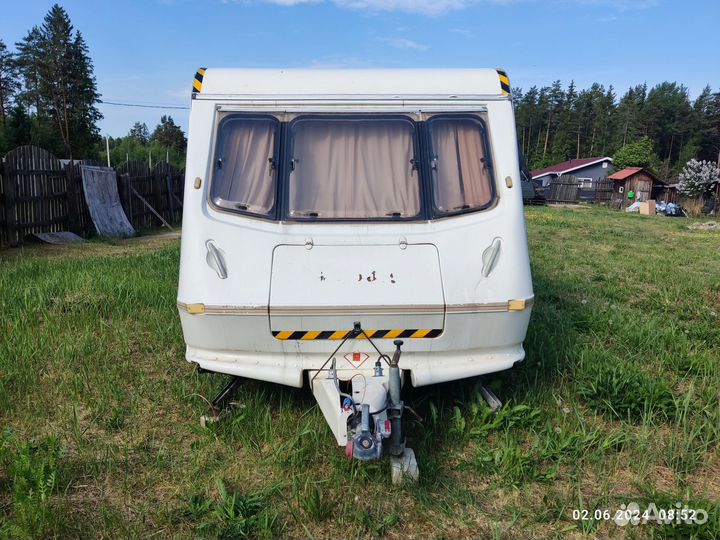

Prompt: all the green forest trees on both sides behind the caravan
xmin=0 ymin=4 xmax=720 ymax=180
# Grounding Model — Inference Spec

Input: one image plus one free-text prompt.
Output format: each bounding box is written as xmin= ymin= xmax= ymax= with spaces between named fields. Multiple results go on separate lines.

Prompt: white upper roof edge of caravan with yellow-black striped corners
xmin=193 ymin=68 xmax=510 ymax=98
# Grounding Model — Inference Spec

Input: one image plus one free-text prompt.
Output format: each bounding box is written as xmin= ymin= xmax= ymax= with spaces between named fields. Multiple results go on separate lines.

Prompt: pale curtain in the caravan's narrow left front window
xmin=211 ymin=118 xmax=275 ymax=214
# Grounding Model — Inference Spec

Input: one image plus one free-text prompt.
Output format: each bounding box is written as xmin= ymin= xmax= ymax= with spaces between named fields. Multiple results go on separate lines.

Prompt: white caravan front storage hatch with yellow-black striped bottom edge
xmin=270 ymin=244 xmax=445 ymax=340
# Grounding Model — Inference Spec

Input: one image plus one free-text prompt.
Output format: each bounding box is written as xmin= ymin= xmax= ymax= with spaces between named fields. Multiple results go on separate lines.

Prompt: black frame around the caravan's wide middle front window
xmin=280 ymin=113 xmax=428 ymax=223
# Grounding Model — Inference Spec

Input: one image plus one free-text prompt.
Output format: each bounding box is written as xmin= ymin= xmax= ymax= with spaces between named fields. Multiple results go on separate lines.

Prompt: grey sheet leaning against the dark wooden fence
xmin=80 ymin=165 xmax=135 ymax=236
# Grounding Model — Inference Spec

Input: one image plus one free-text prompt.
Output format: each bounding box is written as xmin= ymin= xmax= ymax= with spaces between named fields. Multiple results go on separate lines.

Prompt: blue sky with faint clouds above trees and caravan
xmin=0 ymin=0 xmax=720 ymax=136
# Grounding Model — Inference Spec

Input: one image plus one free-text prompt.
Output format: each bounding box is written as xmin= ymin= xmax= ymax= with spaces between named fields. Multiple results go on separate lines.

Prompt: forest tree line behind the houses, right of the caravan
xmin=513 ymin=81 xmax=720 ymax=178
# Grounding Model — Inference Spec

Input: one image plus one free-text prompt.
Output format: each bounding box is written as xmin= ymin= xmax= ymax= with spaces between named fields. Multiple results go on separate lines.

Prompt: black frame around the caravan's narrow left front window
xmin=207 ymin=112 xmax=283 ymax=222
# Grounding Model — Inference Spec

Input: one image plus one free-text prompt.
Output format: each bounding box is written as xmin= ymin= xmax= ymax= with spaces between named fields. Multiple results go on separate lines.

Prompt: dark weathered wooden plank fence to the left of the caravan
xmin=0 ymin=146 xmax=184 ymax=250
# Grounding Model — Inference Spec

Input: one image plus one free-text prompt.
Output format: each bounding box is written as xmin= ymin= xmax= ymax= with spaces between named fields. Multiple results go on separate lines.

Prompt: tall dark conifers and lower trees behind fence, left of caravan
xmin=0 ymin=4 xmax=187 ymax=168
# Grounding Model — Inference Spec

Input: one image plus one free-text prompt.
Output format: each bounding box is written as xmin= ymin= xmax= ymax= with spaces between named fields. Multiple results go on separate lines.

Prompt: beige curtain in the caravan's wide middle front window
xmin=289 ymin=119 xmax=420 ymax=219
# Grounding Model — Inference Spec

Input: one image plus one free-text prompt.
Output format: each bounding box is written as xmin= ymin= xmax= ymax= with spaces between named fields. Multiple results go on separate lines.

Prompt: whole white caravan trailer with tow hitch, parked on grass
xmin=177 ymin=68 xmax=533 ymax=480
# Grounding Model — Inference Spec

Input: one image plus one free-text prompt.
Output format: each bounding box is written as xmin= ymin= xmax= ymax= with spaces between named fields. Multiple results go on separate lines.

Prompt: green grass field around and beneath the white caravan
xmin=0 ymin=208 xmax=720 ymax=539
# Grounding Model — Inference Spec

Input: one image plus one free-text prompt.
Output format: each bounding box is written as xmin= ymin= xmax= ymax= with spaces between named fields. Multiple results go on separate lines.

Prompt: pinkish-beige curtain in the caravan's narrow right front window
xmin=431 ymin=118 xmax=492 ymax=212
